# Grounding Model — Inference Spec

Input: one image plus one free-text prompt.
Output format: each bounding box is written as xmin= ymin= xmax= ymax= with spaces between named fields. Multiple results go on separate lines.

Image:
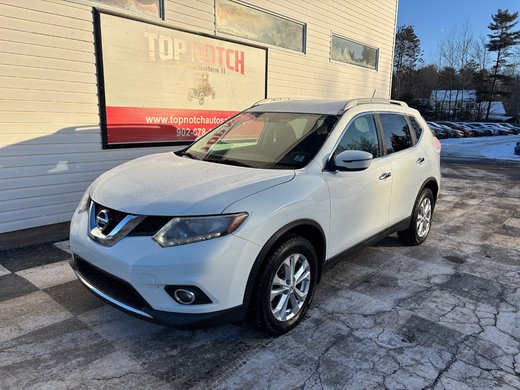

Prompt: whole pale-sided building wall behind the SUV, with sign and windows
xmin=0 ymin=0 xmax=397 ymax=234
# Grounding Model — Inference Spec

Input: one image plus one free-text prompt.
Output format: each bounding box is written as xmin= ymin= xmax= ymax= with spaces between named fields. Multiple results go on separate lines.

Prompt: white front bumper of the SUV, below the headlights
xmin=70 ymin=212 xmax=261 ymax=328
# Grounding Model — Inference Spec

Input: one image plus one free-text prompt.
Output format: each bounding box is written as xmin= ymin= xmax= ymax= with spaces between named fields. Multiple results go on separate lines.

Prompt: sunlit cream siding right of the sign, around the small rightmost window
xmin=226 ymin=0 xmax=396 ymax=98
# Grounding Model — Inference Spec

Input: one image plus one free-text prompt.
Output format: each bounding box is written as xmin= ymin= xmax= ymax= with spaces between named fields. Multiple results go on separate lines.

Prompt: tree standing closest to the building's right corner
xmin=393 ymin=26 xmax=422 ymax=99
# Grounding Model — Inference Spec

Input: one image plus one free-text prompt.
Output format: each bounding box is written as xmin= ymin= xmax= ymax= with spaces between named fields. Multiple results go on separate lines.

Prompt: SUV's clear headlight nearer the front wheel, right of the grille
xmin=153 ymin=213 xmax=248 ymax=247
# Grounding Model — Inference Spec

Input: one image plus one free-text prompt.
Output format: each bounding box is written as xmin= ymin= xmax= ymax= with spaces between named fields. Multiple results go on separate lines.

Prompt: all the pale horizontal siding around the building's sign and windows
xmin=0 ymin=0 xmax=397 ymax=233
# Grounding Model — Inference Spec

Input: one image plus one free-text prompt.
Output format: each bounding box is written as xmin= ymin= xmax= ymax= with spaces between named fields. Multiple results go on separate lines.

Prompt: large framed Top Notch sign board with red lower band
xmin=96 ymin=13 xmax=267 ymax=148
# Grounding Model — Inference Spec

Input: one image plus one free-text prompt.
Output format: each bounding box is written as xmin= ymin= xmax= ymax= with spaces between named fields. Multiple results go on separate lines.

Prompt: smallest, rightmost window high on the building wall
xmin=330 ymin=34 xmax=379 ymax=69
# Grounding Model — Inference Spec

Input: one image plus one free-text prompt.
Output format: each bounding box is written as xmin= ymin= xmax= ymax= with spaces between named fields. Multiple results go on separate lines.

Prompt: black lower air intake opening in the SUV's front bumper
xmin=72 ymin=255 xmax=149 ymax=309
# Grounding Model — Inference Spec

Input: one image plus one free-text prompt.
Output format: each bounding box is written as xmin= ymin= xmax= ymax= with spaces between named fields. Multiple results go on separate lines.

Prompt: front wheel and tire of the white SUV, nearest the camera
xmin=250 ymin=234 xmax=318 ymax=336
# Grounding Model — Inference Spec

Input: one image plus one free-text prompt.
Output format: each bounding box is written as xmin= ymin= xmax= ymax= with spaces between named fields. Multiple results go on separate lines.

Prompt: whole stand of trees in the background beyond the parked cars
xmin=392 ymin=9 xmax=520 ymax=120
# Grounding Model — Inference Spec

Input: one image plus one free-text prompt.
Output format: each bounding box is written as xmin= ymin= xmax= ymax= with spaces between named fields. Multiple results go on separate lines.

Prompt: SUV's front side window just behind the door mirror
xmin=333 ymin=115 xmax=380 ymax=158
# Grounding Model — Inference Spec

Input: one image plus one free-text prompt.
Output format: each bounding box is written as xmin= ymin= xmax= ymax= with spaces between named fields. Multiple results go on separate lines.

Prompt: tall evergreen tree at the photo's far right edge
xmin=486 ymin=9 xmax=520 ymax=120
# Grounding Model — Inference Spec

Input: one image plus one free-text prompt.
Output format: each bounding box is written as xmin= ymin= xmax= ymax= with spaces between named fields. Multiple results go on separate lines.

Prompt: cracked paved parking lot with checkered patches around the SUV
xmin=0 ymin=159 xmax=520 ymax=389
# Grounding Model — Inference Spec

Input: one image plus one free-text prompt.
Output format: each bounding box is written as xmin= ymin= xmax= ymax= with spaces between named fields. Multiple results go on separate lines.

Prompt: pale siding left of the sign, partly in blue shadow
xmin=0 ymin=0 xmax=173 ymax=233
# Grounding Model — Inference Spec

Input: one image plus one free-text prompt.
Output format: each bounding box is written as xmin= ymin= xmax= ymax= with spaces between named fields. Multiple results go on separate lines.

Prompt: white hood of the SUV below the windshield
xmin=90 ymin=152 xmax=294 ymax=216
